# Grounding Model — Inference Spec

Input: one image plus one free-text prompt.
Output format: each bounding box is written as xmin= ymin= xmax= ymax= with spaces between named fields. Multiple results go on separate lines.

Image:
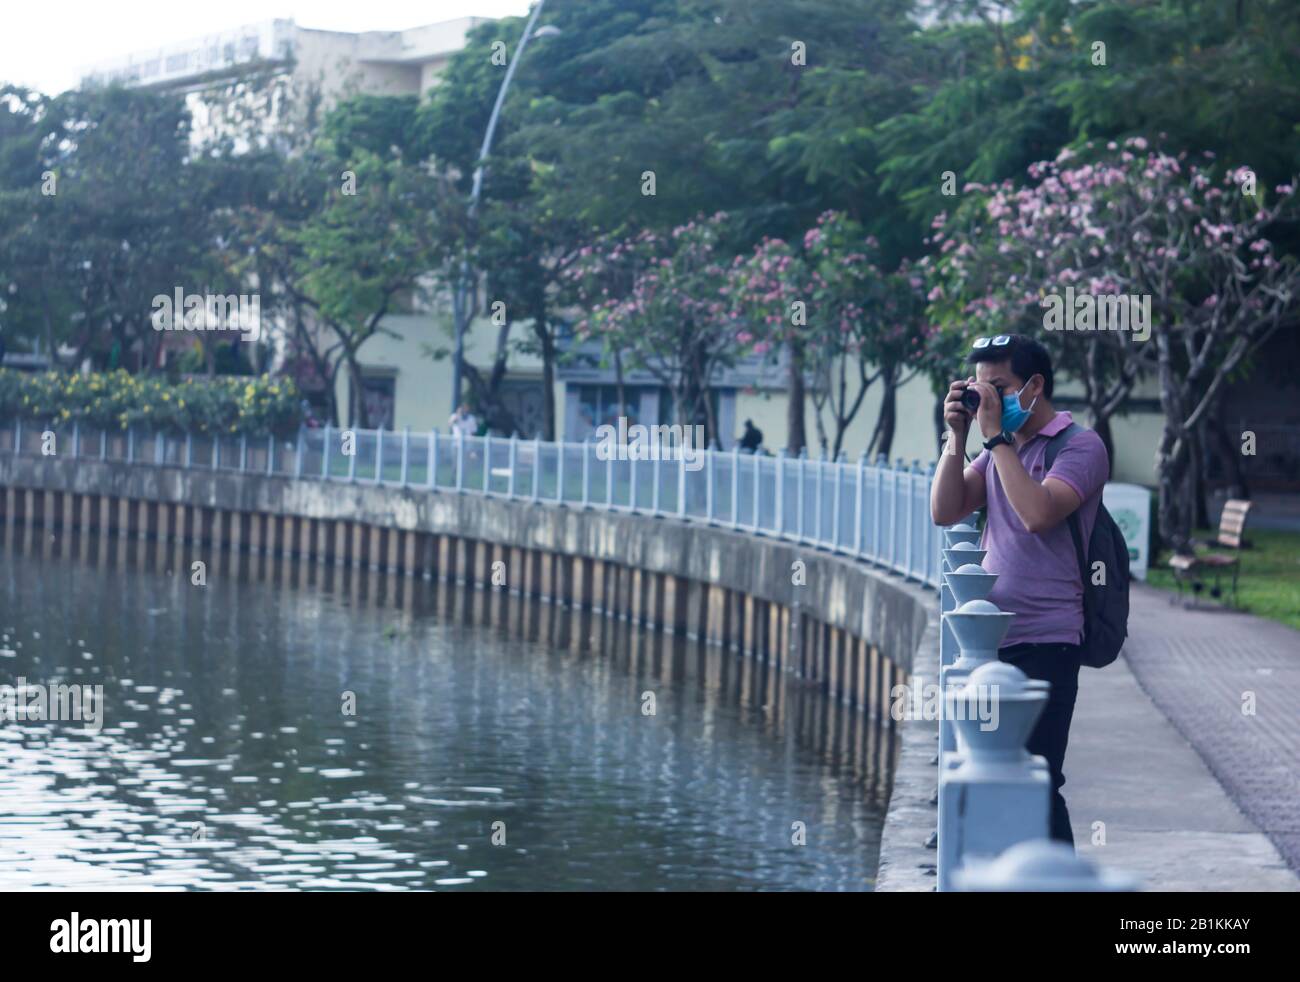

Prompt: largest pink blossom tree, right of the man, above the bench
xmin=924 ymin=137 xmax=1300 ymax=553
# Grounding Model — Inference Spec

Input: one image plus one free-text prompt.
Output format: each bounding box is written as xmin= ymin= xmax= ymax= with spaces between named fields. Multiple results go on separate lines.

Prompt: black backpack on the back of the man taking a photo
xmin=1043 ymin=423 xmax=1130 ymax=669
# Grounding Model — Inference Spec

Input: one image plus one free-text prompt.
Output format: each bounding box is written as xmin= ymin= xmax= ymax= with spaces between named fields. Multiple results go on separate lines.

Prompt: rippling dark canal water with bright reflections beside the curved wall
xmin=0 ymin=529 xmax=893 ymax=891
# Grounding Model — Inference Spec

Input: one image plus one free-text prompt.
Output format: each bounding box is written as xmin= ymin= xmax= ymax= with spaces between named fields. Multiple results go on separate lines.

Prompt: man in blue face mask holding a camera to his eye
xmin=930 ymin=334 xmax=1110 ymax=845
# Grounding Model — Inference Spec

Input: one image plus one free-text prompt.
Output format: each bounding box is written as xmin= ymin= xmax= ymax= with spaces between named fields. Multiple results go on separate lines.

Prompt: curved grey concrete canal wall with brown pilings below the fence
xmin=0 ymin=455 xmax=939 ymax=891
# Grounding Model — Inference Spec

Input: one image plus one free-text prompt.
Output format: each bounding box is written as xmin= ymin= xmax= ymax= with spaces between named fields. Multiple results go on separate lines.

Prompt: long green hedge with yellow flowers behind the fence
xmin=0 ymin=368 xmax=302 ymax=436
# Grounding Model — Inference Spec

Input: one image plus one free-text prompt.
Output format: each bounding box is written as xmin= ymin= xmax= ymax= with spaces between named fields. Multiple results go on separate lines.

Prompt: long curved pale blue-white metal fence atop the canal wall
xmin=0 ymin=421 xmax=941 ymax=588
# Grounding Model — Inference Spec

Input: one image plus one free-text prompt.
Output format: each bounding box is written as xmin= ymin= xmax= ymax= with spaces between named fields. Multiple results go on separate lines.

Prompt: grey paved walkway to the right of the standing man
xmin=1063 ymin=583 xmax=1300 ymax=891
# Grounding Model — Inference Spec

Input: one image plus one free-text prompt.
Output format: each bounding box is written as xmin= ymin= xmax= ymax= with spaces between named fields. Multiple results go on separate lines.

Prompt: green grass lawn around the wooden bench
xmin=1147 ymin=523 xmax=1300 ymax=630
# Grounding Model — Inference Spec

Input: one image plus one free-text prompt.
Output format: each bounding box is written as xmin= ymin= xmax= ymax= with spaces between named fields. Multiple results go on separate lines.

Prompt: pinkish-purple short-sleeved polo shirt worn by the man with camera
xmin=971 ymin=412 xmax=1110 ymax=648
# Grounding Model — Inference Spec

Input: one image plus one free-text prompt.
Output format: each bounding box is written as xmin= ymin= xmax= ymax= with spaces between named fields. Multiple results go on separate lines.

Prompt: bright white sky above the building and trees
xmin=0 ymin=0 xmax=530 ymax=95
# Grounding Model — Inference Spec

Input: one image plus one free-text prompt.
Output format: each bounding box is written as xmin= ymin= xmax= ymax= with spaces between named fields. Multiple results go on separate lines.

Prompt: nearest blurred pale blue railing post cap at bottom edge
xmin=953 ymin=839 xmax=1140 ymax=892
